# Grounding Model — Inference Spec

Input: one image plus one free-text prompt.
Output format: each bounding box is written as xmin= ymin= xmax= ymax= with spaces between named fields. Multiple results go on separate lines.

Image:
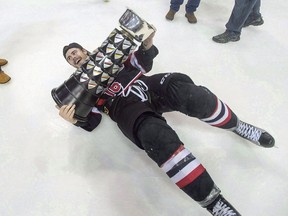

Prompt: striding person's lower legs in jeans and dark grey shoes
xmin=212 ymin=0 xmax=264 ymax=43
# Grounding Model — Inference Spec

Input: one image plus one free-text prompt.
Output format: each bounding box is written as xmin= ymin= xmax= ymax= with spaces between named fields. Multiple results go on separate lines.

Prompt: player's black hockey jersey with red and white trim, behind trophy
xmin=75 ymin=45 xmax=158 ymax=131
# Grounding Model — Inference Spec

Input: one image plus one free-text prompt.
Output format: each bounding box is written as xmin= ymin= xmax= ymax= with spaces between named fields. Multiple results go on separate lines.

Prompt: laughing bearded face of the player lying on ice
xmin=65 ymin=48 xmax=88 ymax=68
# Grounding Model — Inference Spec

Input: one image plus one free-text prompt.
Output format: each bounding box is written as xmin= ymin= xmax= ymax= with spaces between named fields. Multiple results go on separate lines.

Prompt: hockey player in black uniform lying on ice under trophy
xmin=59 ymin=30 xmax=275 ymax=216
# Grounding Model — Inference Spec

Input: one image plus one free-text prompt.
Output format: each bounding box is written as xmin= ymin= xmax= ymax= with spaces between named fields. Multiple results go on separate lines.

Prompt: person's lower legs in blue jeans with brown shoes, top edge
xmin=165 ymin=0 xmax=200 ymax=23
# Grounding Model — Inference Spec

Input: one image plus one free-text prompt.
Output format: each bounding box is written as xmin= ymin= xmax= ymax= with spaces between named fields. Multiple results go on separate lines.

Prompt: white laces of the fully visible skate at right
xmin=236 ymin=121 xmax=262 ymax=142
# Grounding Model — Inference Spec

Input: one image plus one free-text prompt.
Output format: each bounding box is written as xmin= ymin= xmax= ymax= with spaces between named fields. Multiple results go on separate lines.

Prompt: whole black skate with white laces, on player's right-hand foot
xmin=233 ymin=120 xmax=275 ymax=148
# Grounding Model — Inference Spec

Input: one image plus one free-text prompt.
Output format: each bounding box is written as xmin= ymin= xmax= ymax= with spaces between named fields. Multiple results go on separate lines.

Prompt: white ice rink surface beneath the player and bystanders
xmin=0 ymin=0 xmax=288 ymax=216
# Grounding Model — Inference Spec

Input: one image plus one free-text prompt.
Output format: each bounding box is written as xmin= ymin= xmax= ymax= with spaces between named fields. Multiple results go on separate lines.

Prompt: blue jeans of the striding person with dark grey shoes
xmin=225 ymin=0 xmax=261 ymax=34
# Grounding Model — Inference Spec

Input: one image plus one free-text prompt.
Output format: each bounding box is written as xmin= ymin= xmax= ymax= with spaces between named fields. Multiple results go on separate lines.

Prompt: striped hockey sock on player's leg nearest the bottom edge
xmin=161 ymin=145 xmax=218 ymax=202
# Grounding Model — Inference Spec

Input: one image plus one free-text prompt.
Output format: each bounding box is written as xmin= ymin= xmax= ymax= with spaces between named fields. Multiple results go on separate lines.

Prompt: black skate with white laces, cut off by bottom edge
xmin=207 ymin=195 xmax=241 ymax=216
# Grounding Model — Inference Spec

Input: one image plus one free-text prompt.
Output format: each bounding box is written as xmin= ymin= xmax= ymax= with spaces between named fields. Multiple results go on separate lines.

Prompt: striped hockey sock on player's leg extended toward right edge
xmin=201 ymin=97 xmax=237 ymax=129
